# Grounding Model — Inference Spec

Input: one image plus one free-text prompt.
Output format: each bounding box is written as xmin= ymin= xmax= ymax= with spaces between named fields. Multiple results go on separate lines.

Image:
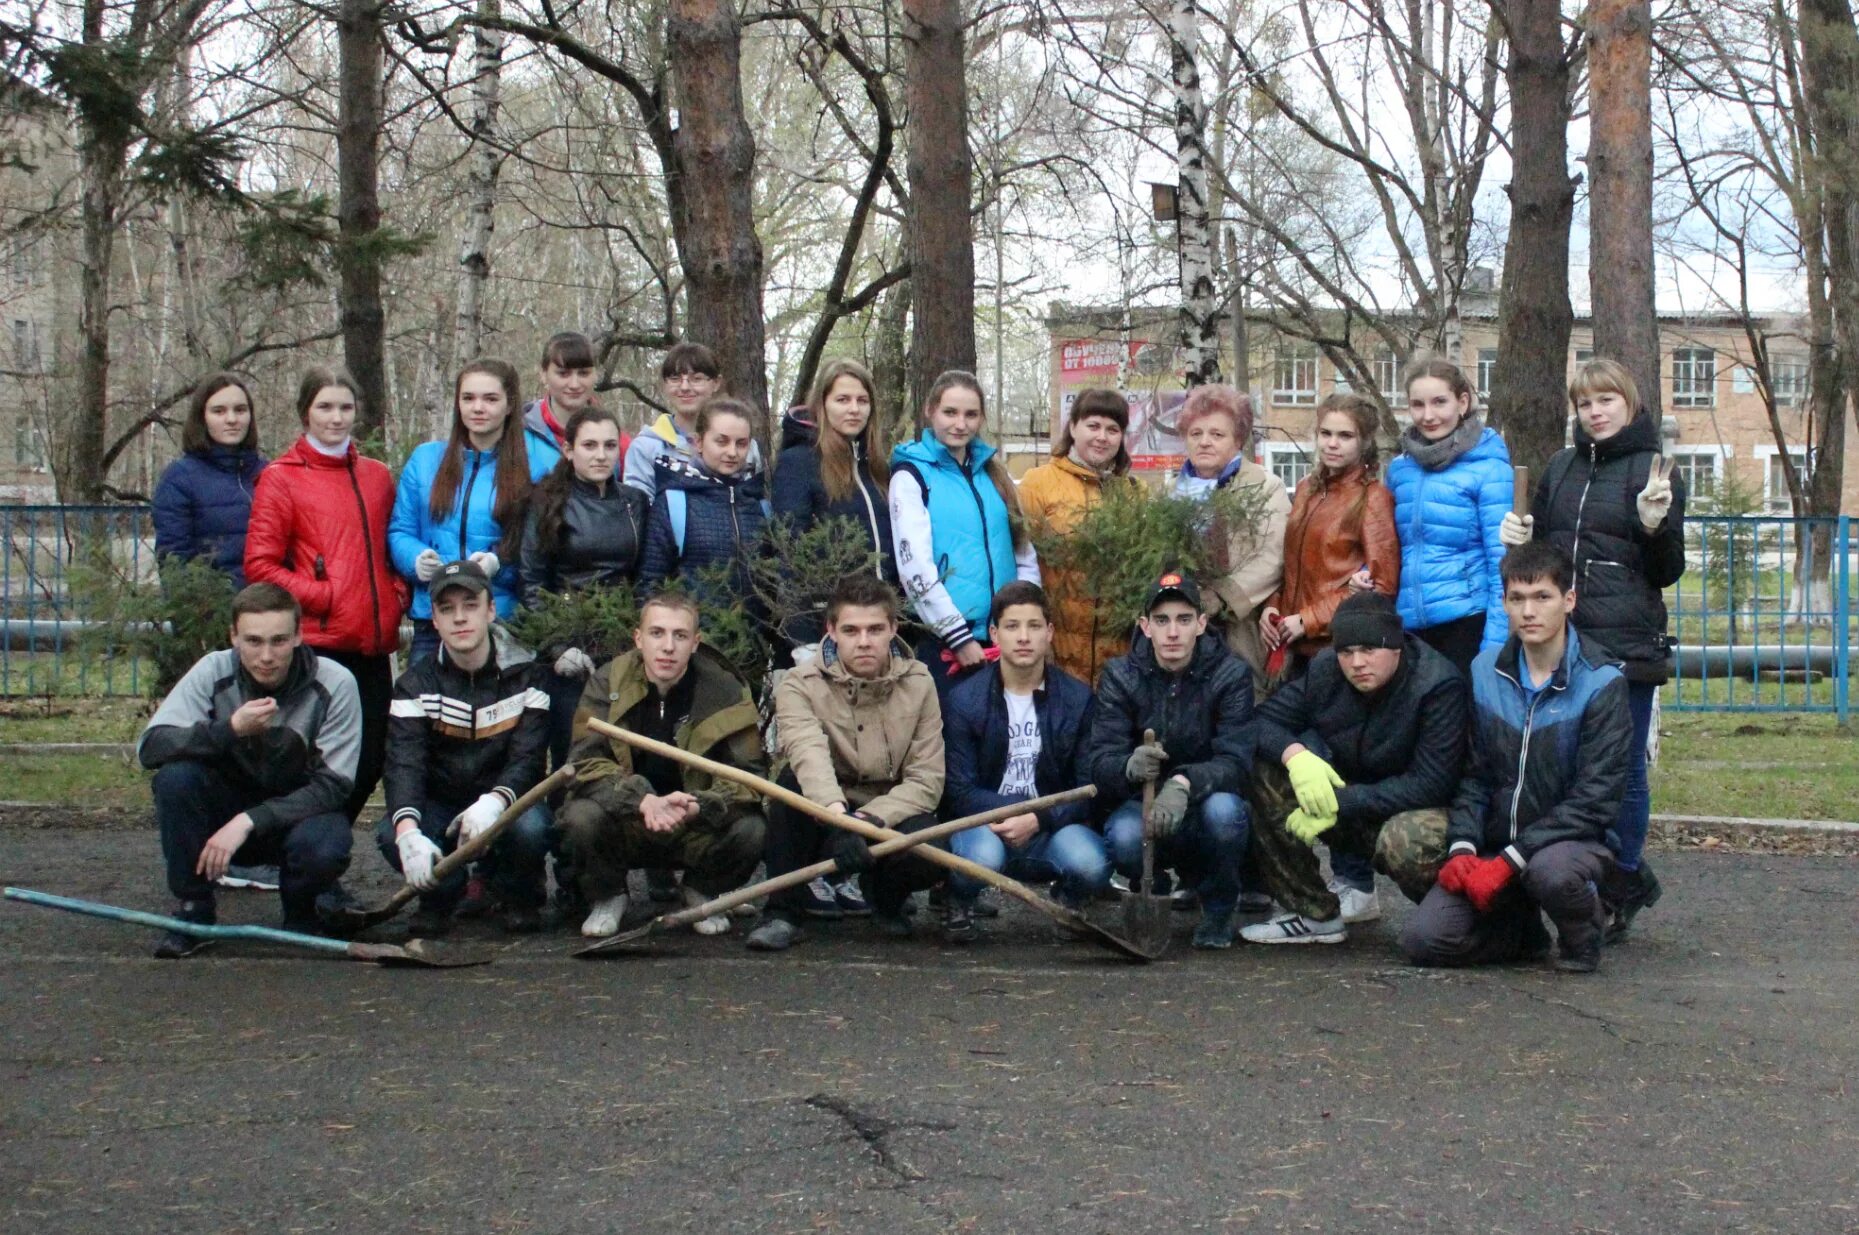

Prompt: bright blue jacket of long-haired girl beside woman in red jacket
xmin=387 ymin=433 xmax=546 ymax=619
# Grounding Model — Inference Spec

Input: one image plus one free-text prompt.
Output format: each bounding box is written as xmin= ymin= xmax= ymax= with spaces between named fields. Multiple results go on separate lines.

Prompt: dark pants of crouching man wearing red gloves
xmin=1400 ymin=841 xmax=1614 ymax=965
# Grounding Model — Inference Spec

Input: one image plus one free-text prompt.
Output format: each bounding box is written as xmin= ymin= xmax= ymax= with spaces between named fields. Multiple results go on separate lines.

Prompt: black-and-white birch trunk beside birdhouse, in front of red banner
xmin=1167 ymin=0 xmax=1220 ymax=389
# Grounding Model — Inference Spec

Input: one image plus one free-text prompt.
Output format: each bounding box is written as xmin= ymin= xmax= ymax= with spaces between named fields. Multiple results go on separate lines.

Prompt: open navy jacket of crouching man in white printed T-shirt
xmin=943 ymin=662 xmax=1095 ymax=831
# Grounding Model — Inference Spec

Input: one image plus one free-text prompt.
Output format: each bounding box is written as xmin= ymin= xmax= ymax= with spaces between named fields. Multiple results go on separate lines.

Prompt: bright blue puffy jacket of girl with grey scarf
xmin=1387 ymin=430 xmax=1511 ymax=649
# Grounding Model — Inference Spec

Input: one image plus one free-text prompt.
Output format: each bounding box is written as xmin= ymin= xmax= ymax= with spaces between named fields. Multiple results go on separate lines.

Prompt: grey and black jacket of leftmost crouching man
xmin=136 ymin=647 xmax=361 ymax=835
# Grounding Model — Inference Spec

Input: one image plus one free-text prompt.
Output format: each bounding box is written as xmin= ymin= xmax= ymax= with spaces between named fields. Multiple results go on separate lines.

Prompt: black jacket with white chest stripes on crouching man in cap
xmin=385 ymin=627 xmax=548 ymax=824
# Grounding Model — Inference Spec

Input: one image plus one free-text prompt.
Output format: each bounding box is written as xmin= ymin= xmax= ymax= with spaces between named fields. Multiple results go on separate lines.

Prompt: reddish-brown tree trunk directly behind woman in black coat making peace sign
xmin=1588 ymin=0 xmax=1662 ymax=417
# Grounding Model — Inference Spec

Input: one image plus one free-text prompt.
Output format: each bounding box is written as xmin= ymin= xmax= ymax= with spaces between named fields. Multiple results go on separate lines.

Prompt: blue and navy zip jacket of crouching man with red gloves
xmin=1446 ymin=627 xmax=1632 ymax=870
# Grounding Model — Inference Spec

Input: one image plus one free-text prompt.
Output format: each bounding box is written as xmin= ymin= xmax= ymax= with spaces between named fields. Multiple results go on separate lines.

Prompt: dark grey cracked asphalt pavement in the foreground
xmin=0 ymin=828 xmax=1859 ymax=1235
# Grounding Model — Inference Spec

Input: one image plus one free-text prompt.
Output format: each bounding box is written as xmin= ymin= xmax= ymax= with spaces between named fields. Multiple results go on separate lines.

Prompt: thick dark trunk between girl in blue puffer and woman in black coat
xmin=1491 ymin=0 xmax=1575 ymax=469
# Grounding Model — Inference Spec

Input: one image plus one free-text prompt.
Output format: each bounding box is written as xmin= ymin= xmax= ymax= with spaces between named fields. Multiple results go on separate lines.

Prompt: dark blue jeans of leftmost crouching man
xmin=154 ymin=759 xmax=353 ymax=921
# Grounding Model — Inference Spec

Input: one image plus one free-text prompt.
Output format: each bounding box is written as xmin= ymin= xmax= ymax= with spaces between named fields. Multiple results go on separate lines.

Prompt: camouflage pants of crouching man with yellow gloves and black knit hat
xmin=1251 ymin=761 xmax=1446 ymax=921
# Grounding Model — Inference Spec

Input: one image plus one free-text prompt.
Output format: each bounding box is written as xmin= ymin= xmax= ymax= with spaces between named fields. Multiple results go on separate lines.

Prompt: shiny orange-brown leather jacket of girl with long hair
xmin=1266 ymin=465 xmax=1400 ymax=657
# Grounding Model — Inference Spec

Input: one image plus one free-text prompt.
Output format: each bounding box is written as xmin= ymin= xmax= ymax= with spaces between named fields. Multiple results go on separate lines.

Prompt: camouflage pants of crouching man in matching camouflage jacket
xmin=556 ymin=798 xmax=764 ymax=900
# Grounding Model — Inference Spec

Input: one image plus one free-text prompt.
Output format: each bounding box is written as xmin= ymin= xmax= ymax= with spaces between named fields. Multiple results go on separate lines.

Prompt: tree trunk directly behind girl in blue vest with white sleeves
xmin=903 ymin=0 xmax=976 ymax=409
